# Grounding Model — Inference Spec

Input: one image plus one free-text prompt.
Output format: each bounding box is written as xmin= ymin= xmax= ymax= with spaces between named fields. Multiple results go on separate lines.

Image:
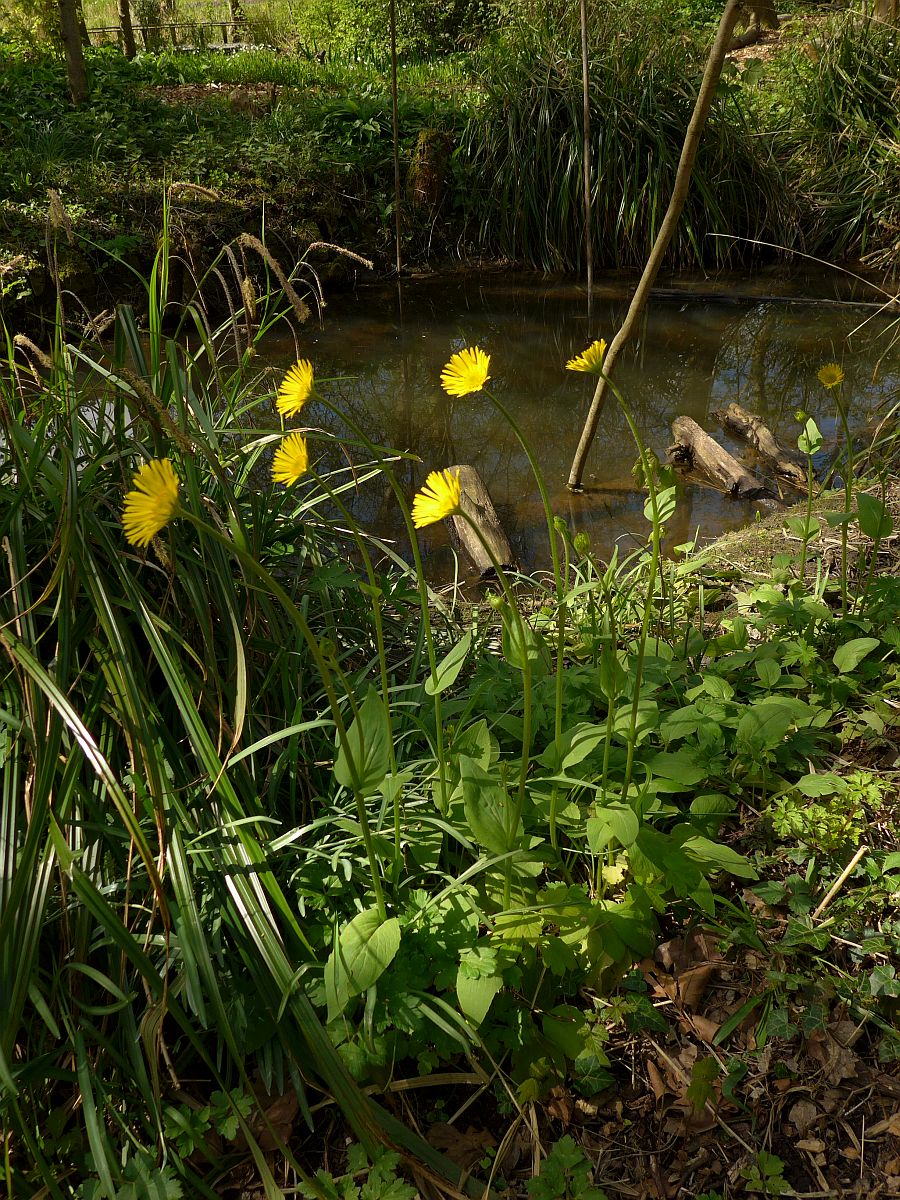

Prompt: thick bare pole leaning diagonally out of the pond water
xmin=568 ymin=0 xmax=740 ymax=492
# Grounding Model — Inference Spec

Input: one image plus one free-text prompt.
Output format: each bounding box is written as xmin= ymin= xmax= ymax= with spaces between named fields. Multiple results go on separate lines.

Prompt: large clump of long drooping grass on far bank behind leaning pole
xmin=466 ymin=8 xmax=792 ymax=269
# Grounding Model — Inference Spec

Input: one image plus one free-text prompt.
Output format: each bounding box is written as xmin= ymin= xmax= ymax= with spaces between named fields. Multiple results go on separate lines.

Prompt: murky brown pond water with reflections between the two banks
xmin=256 ymin=275 xmax=900 ymax=577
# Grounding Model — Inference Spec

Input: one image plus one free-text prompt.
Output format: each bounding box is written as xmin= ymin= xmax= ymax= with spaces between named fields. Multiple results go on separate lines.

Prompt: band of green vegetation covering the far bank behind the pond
xmin=0 ymin=4 xmax=900 ymax=314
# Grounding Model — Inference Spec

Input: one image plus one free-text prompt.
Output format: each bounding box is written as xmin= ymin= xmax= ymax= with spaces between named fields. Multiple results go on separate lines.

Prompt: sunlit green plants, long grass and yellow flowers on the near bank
xmin=0 ymin=238 xmax=900 ymax=1200
